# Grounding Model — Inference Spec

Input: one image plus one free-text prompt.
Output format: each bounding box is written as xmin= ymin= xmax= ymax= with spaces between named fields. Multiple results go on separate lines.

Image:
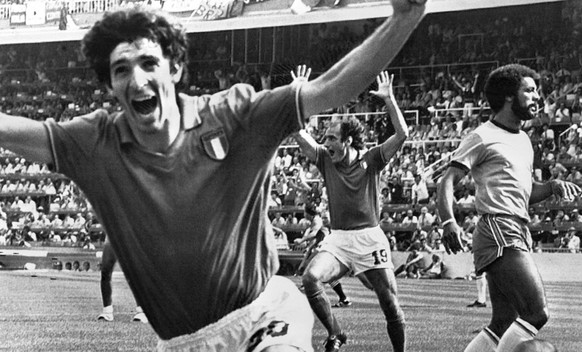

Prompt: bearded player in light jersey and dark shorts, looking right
xmin=438 ymin=65 xmax=580 ymax=352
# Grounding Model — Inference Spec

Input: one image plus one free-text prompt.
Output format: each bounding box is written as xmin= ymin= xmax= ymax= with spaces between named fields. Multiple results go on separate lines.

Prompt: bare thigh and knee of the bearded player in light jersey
xmin=487 ymin=248 xmax=547 ymax=318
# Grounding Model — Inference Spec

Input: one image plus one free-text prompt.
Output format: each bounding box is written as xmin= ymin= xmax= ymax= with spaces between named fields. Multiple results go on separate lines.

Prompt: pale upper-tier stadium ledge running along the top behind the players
xmin=0 ymin=0 xmax=565 ymax=45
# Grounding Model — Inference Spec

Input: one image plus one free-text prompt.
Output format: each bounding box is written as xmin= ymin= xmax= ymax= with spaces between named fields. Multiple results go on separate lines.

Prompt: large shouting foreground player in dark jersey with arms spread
xmin=0 ymin=0 xmax=425 ymax=351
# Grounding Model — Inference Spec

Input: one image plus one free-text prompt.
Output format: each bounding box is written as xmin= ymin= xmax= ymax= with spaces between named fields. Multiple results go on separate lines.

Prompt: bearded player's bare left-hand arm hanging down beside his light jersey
xmin=437 ymin=167 xmax=465 ymax=253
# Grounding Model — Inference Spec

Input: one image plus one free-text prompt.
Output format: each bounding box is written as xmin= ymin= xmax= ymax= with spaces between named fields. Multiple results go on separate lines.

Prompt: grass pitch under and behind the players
xmin=0 ymin=271 xmax=582 ymax=352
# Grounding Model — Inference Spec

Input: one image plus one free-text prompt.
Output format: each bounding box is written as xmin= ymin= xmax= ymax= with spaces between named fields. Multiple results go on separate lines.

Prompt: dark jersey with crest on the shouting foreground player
xmin=45 ymin=84 xmax=302 ymax=339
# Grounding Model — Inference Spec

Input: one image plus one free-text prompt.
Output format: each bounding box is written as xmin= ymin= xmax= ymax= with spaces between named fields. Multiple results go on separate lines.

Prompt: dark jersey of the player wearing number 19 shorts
xmin=315 ymin=145 xmax=386 ymax=230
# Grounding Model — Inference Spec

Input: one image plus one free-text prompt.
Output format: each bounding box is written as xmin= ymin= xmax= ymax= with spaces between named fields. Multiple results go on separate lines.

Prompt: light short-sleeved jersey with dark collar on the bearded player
xmin=451 ymin=121 xmax=533 ymax=221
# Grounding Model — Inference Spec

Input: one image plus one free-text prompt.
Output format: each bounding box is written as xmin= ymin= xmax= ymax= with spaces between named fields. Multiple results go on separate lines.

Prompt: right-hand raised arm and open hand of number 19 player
xmin=370 ymin=71 xmax=408 ymax=161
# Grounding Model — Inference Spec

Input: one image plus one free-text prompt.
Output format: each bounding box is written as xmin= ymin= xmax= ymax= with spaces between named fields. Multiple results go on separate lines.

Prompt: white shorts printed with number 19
xmin=319 ymin=226 xmax=394 ymax=275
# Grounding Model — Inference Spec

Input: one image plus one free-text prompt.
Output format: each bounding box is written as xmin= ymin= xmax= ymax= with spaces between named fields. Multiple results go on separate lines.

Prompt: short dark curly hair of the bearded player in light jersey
xmin=485 ymin=64 xmax=539 ymax=113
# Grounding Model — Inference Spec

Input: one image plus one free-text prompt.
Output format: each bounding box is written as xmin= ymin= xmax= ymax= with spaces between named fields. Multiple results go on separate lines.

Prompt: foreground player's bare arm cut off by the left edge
xmin=0 ymin=113 xmax=53 ymax=164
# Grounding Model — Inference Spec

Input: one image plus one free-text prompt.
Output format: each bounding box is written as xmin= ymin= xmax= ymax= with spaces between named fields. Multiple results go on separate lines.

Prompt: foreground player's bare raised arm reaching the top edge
xmin=300 ymin=0 xmax=426 ymax=119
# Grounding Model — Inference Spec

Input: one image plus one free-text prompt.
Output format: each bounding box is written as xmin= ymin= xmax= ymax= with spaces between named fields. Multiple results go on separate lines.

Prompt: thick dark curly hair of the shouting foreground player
xmin=81 ymin=5 xmax=188 ymax=87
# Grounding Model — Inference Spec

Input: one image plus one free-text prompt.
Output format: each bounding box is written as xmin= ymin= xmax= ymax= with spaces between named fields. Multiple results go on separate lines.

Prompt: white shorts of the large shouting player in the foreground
xmin=158 ymin=276 xmax=314 ymax=352
